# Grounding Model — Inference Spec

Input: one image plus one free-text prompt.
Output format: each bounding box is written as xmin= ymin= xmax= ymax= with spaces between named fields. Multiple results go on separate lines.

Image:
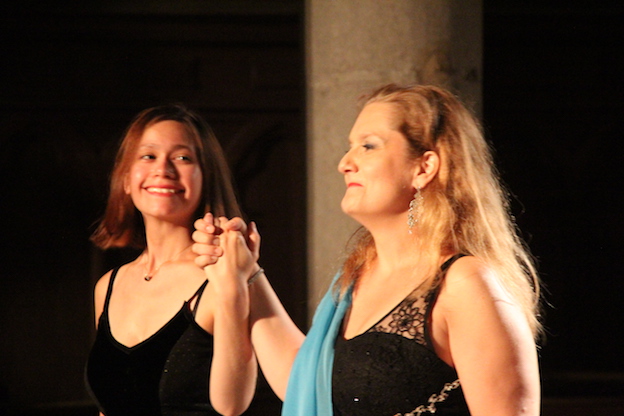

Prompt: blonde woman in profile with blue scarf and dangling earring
xmin=193 ymin=84 xmax=540 ymax=416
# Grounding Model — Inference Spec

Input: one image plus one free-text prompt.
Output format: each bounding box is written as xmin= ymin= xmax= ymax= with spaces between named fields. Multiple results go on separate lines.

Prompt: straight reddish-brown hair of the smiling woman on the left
xmin=91 ymin=104 xmax=241 ymax=249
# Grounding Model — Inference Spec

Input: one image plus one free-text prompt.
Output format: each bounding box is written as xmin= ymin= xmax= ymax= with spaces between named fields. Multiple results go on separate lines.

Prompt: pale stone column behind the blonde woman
xmin=305 ymin=0 xmax=482 ymax=319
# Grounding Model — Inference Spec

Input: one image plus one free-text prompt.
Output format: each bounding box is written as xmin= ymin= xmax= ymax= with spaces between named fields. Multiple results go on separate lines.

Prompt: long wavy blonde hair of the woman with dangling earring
xmin=337 ymin=84 xmax=542 ymax=338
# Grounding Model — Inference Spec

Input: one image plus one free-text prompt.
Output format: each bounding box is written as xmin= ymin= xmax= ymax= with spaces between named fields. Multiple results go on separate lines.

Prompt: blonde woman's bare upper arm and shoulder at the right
xmin=433 ymin=257 xmax=540 ymax=416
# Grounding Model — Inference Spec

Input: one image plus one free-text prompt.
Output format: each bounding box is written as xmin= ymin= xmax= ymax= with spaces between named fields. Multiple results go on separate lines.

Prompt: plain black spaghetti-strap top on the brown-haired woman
xmin=85 ymin=269 xmax=218 ymax=416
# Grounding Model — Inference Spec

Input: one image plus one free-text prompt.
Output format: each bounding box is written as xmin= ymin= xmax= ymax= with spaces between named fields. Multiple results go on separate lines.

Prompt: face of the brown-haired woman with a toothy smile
xmin=124 ymin=120 xmax=202 ymax=225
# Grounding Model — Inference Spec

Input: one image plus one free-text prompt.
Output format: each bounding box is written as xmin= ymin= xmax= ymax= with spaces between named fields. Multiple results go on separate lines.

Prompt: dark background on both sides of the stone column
xmin=0 ymin=0 xmax=624 ymax=416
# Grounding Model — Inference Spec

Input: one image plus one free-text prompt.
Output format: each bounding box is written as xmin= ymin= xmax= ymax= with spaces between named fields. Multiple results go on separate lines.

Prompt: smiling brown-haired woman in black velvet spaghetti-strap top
xmin=86 ymin=105 xmax=257 ymax=416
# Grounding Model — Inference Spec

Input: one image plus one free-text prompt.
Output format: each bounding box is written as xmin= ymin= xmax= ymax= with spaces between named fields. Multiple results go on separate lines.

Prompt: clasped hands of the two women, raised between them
xmin=192 ymin=213 xmax=260 ymax=287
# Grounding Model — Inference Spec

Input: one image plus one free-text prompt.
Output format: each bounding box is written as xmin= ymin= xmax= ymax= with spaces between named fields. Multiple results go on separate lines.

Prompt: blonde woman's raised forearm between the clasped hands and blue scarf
xmin=250 ymin=275 xmax=305 ymax=400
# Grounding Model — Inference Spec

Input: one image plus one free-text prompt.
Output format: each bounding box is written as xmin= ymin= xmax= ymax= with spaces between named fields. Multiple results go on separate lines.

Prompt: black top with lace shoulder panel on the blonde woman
xmin=332 ymin=255 xmax=470 ymax=416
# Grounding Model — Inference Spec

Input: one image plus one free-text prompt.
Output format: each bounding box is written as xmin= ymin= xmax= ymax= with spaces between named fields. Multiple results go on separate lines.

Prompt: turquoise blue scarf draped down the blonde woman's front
xmin=282 ymin=275 xmax=351 ymax=416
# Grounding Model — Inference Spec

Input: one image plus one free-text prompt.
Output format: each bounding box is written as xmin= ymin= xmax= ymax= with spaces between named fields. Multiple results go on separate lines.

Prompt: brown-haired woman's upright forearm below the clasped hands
xmin=210 ymin=282 xmax=258 ymax=415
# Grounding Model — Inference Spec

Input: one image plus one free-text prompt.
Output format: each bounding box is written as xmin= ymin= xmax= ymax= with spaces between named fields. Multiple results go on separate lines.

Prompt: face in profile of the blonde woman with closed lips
xmin=338 ymin=103 xmax=416 ymax=225
